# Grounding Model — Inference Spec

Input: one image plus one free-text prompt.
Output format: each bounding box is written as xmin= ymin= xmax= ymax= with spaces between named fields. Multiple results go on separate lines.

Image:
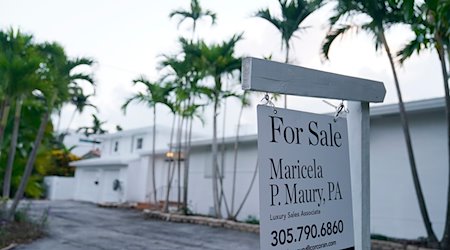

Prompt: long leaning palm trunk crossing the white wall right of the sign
xmin=381 ymin=31 xmax=437 ymax=244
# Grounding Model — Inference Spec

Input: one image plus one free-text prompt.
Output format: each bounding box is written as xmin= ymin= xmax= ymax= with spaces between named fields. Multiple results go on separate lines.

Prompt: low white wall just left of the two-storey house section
xmin=44 ymin=176 xmax=75 ymax=200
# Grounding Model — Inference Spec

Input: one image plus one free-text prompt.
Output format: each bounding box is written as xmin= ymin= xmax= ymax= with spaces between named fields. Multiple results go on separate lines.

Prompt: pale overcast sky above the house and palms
xmin=0 ymin=0 xmax=444 ymax=135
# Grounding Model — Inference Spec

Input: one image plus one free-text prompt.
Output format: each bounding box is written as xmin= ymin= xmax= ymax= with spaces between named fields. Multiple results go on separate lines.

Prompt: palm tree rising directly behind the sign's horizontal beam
xmin=255 ymin=0 xmax=322 ymax=108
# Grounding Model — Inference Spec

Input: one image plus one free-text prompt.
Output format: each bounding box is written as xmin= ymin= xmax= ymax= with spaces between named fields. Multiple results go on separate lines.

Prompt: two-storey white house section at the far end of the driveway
xmin=73 ymin=126 xmax=190 ymax=203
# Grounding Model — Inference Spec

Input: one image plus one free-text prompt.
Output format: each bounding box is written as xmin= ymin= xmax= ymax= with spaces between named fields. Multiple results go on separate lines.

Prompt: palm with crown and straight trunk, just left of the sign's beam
xmin=184 ymin=34 xmax=242 ymax=218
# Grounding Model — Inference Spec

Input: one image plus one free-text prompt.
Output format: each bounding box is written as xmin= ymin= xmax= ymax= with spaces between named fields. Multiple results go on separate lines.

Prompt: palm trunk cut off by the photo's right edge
xmin=436 ymin=35 xmax=450 ymax=249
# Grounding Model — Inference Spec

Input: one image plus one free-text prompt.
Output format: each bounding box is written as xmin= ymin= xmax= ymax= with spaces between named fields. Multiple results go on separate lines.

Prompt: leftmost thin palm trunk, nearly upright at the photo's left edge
xmin=3 ymin=96 xmax=23 ymax=199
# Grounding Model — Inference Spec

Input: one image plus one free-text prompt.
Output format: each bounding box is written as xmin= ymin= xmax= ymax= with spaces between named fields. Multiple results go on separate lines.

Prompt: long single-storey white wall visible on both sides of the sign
xmin=172 ymin=107 xmax=448 ymax=239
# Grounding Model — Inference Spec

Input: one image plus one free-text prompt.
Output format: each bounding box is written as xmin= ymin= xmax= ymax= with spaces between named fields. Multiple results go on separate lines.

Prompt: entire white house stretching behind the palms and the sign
xmin=66 ymin=98 xmax=449 ymax=238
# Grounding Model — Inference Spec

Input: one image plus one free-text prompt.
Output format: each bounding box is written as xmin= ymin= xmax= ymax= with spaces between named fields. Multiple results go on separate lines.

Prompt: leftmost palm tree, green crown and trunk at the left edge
xmin=0 ymin=28 xmax=40 ymax=198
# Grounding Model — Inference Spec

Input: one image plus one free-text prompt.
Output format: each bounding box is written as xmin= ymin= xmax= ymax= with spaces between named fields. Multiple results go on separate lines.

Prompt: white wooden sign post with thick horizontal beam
xmin=242 ymin=58 xmax=386 ymax=249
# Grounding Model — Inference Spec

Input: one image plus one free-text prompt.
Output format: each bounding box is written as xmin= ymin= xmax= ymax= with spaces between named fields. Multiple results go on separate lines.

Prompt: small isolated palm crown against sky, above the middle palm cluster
xmin=169 ymin=0 xmax=216 ymax=35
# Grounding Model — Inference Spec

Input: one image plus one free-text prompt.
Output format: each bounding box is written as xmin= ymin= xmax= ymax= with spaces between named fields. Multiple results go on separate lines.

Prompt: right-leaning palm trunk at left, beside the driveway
xmin=8 ymin=95 xmax=56 ymax=220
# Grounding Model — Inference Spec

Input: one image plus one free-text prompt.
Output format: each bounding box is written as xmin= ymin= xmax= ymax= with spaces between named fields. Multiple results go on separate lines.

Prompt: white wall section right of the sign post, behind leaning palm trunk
xmin=370 ymin=111 xmax=448 ymax=238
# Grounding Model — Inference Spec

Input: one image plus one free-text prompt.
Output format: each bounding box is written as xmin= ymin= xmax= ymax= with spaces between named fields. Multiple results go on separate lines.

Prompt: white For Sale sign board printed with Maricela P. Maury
xmin=258 ymin=105 xmax=354 ymax=250
